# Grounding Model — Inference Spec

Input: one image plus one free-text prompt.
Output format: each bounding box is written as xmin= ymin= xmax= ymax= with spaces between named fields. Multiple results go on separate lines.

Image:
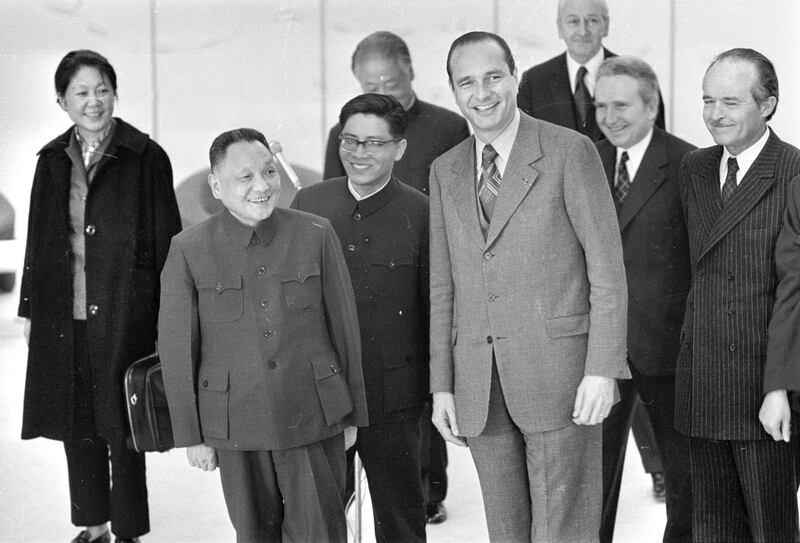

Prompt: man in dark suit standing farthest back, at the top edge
xmin=517 ymin=0 xmax=664 ymax=141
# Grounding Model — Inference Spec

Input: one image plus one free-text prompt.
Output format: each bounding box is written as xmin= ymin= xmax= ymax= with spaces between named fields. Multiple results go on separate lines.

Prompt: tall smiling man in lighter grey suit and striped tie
xmin=430 ymin=32 xmax=628 ymax=541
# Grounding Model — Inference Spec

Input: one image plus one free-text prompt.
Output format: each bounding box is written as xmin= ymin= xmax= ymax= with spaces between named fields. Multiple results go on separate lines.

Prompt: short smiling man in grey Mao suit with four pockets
xmin=158 ymin=128 xmax=367 ymax=542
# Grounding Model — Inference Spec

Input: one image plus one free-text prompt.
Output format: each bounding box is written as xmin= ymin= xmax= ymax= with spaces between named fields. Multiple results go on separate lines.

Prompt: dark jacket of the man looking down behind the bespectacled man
xmin=322 ymin=98 xmax=469 ymax=194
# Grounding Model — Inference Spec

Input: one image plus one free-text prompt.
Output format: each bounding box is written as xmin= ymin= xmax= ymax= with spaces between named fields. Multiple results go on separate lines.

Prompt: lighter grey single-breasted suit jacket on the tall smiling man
xmin=430 ymin=113 xmax=629 ymax=436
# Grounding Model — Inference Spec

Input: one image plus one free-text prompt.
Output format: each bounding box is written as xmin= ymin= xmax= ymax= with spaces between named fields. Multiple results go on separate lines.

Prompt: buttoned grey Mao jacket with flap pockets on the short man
xmin=158 ymin=209 xmax=367 ymax=450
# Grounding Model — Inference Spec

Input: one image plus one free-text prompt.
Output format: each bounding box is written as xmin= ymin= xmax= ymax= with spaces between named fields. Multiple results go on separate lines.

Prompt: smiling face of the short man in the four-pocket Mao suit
xmin=208 ymin=141 xmax=281 ymax=227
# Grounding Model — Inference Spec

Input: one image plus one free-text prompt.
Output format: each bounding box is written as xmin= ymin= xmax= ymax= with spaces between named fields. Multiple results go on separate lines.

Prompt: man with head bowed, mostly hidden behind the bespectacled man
xmin=322 ymin=31 xmax=469 ymax=524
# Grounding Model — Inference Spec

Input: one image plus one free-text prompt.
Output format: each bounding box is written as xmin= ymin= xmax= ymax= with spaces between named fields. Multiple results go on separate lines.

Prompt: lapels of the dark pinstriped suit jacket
xmin=700 ymin=133 xmax=780 ymax=258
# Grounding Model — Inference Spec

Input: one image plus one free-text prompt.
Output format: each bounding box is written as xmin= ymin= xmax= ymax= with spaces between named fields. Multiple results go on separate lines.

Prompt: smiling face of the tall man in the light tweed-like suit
xmin=450 ymin=40 xmax=519 ymax=143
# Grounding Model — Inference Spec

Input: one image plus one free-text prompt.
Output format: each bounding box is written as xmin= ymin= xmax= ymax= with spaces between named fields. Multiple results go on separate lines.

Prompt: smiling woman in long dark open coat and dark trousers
xmin=19 ymin=51 xmax=181 ymax=543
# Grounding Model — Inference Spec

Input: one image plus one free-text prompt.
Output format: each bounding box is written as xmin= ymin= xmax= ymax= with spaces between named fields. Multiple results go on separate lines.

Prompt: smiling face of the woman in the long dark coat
xmin=58 ymin=66 xmax=116 ymax=141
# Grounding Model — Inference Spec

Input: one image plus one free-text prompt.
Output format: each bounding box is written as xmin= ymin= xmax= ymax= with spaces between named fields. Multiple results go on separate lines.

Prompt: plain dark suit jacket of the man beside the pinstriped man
xmin=597 ymin=127 xmax=695 ymax=375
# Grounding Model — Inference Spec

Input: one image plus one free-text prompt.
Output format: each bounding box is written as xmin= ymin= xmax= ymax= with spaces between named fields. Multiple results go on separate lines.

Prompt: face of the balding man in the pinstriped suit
xmin=703 ymin=59 xmax=777 ymax=155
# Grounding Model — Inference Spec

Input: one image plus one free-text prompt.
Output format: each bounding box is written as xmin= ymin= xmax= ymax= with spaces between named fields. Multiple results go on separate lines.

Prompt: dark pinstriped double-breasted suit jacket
xmin=675 ymin=130 xmax=800 ymax=440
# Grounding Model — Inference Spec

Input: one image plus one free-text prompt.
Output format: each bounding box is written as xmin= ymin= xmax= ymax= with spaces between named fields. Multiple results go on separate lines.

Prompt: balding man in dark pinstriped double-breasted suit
xmin=675 ymin=49 xmax=800 ymax=541
